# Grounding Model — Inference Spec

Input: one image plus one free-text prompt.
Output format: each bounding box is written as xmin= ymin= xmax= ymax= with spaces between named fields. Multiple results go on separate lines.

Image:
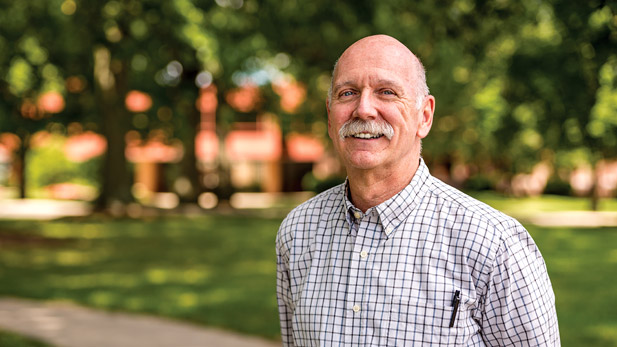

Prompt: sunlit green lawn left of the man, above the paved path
xmin=0 ymin=216 xmax=280 ymax=338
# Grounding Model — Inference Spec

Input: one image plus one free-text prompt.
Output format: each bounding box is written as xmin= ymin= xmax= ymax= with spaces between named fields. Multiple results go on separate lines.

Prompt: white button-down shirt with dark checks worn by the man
xmin=276 ymin=160 xmax=560 ymax=346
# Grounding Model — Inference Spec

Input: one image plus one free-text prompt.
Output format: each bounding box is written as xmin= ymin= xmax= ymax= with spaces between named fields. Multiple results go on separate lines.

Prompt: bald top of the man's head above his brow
xmin=328 ymin=35 xmax=429 ymax=108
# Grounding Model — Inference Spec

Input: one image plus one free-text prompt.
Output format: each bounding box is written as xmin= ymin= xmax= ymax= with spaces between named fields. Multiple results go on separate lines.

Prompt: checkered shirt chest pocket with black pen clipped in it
xmin=382 ymin=296 xmax=476 ymax=346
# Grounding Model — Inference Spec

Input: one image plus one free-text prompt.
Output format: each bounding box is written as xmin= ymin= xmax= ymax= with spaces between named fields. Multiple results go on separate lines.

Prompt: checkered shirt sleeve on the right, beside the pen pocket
xmin=482 ymin=225 xmax=560 ymax=346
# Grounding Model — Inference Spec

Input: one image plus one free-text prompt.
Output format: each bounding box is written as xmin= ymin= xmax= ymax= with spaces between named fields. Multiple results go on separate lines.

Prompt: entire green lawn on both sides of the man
xmin=0 ymin=197 xmax=617 ymax=346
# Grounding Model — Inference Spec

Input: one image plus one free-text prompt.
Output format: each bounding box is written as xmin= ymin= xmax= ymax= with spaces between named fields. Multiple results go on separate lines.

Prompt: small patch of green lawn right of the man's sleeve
xmin=527 ymin=226 xmax=617 ymax=347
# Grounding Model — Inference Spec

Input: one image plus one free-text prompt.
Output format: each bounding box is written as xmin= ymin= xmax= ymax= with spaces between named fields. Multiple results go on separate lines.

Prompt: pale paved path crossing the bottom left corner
xmin=0 ymin=298 xmax=281 ymax=347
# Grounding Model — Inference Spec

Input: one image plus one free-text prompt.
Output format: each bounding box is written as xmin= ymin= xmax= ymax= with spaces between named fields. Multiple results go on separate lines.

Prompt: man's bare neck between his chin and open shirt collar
xmin=347 ymin=158 xmax=420 ymax=212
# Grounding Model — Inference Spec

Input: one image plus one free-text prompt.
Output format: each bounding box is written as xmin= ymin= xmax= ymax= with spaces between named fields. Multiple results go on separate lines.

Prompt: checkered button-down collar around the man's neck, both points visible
xmin=342 ymin=158 xmax=430 ymax=237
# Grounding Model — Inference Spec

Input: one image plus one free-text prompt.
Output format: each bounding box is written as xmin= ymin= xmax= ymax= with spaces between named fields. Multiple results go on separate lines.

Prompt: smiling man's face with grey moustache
xmin=327 ymin=40 xmax=434 ymax=170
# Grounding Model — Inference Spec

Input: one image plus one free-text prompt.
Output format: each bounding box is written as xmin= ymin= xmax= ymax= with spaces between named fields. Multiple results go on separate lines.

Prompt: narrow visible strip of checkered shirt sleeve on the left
xmin=276 ymin=227 xmax=293 ymax=346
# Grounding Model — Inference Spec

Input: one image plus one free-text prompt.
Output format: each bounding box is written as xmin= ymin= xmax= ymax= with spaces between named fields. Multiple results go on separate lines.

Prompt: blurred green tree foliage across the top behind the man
xmin=0 ymin=0 xmax=617 ymax=200
